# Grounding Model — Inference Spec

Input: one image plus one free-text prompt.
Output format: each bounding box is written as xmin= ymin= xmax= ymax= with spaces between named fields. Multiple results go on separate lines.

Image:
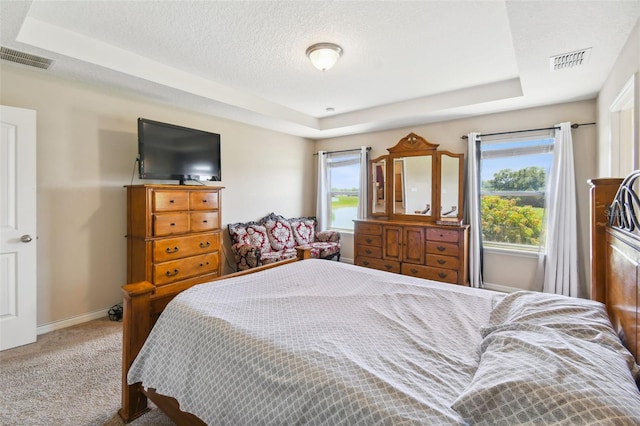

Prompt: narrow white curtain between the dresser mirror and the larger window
xmin=465 ymin=133 xmax=482 ymax=288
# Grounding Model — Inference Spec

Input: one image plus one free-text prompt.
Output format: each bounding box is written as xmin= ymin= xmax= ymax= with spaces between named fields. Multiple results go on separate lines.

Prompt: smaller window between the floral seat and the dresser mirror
xmin=327 ymin=151 xmax=360 ymax=231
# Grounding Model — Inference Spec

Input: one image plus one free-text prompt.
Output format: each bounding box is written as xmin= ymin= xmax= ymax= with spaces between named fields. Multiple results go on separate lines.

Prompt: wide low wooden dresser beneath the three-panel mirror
xmin=354 ymin=219 xmax=469 ymax=285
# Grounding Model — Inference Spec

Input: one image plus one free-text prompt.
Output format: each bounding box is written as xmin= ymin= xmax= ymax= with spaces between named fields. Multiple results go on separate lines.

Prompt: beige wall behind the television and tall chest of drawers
xmin=0 ymin=63 xmax=315 ymax=329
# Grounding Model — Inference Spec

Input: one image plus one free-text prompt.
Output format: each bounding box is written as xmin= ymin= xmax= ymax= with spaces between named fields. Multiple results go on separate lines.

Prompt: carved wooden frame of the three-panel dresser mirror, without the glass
xmin=368 ymin=132 xmax=465 ymax=224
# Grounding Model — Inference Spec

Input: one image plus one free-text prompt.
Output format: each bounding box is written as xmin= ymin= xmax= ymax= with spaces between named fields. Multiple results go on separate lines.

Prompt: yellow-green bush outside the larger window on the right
xmin=481 ymin=195 xmax=542 ymax=245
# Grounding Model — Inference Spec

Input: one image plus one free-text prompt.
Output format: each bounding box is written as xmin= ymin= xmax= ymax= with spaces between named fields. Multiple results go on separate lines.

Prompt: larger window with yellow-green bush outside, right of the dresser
xmin=480 ymin=134 xmax=554 ymax=252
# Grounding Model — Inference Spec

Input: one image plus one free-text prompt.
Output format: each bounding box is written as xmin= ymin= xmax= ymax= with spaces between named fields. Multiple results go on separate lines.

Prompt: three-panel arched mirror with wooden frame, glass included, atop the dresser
xmin=369 ymin=133 xmax=464 ymax=222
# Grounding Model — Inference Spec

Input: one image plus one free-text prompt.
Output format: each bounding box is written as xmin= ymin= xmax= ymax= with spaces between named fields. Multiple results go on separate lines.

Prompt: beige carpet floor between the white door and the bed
xmin=0 ymin=317 xmax=174 ymax=426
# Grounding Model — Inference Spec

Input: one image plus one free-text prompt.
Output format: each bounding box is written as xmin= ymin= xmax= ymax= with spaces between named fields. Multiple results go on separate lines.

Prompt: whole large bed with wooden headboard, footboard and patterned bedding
xmin=119 ymin=176 xmax=640 ymax=425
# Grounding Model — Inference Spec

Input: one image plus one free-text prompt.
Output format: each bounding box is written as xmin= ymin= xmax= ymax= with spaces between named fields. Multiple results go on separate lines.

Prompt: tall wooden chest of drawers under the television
xmin=126 ymin=185 xmax=222 ymax=287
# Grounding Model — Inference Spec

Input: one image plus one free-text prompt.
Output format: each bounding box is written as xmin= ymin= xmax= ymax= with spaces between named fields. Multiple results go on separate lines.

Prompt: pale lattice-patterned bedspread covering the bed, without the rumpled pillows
xmin=128 ymin=260 xmax=500 ymax=425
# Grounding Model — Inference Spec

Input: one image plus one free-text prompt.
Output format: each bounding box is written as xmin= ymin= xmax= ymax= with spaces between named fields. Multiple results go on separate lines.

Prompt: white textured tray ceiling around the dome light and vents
xmin=0 ymin=0 xmax=640 ymax=139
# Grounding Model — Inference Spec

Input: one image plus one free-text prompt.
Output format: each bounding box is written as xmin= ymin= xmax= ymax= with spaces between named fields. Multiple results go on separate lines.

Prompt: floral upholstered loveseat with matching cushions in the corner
xmin=228 ymin=213 xmax=340 ymax=271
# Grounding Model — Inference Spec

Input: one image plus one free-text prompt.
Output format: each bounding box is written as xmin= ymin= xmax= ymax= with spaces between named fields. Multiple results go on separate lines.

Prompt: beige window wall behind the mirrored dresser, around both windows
xmin=315 ymin=100 xmax=596 ymax=296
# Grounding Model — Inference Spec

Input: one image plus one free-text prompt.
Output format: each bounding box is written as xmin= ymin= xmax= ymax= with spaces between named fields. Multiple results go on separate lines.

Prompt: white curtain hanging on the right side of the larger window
xmin=543 ymin=122 xmax=578 ymax=297
